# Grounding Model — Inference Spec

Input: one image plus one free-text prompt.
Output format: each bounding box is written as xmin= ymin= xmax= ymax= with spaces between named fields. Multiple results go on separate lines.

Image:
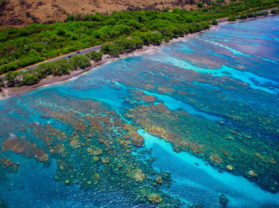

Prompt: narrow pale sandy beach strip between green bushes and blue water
xmin=0 ymin=15 xmax=276 ymax=101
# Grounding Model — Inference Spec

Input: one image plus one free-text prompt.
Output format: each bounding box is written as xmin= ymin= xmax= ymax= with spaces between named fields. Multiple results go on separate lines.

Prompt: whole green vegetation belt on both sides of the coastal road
xmin=0 ymin=0 xmax=279 ymax=87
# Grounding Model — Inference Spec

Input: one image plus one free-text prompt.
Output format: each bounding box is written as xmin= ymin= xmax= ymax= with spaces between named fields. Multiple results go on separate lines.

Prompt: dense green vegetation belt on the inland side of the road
xmin=0 ymin=0 xmax=278 ymax=74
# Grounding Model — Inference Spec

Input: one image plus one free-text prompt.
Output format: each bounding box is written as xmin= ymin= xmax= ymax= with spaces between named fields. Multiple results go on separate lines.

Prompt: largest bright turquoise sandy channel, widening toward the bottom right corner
xmin=139 ymin=130 xmax=279 ymax=207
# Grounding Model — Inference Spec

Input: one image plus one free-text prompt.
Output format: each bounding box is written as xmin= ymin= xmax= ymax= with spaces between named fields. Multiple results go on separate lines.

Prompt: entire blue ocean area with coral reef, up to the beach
xmin=0 ymin=16 xmax=279 ymax=208
